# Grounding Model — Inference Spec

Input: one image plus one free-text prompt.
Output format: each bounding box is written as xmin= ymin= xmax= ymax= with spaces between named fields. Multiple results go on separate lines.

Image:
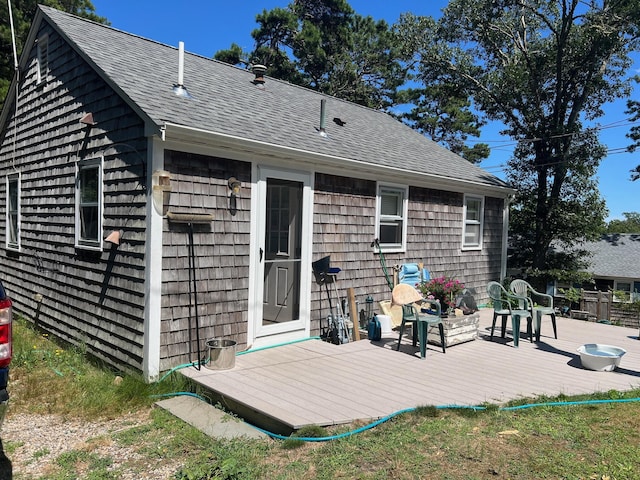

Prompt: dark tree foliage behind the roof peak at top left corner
xmin=0 ymin=0 xmax=108 ymax=108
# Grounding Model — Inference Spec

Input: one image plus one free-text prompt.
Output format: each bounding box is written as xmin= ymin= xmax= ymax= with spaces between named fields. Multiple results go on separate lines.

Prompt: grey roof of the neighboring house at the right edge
xmin=582 ymin=233 xmax=640 ymax=279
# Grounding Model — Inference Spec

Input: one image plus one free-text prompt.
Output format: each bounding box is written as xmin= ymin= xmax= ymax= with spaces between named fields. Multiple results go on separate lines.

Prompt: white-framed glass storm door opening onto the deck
xmin=249 ymin=167 xmax=313 ymax=347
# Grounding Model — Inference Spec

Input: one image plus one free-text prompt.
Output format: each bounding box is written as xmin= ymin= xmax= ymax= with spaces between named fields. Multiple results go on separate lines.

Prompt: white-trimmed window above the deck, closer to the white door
xmin=376 ymin=184 xmax=409 ymax=252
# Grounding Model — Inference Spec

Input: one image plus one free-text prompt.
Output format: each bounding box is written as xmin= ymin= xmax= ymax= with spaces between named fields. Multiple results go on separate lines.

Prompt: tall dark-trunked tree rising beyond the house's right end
xmin=398 ymin=0 xmax=640 ymax=270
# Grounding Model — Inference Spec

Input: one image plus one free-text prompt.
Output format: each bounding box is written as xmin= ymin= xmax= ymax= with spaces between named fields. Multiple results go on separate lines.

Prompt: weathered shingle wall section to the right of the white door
xmin=311 ymin=174 xmax=503 ymax=334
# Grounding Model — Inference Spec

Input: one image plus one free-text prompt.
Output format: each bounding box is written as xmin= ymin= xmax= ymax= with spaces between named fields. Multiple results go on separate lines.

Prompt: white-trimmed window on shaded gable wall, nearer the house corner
xmin=76 ymin=158 xmax=103 ymax=250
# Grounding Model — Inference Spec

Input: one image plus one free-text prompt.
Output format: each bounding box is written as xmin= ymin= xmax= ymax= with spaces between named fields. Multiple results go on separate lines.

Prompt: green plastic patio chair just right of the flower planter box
xmin=487 ymin=282 xmax=533 ymax=347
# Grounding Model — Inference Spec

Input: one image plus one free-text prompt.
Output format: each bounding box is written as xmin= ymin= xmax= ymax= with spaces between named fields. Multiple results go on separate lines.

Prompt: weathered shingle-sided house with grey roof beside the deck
xmin=0 ymin=6 xmax=513 ymax=380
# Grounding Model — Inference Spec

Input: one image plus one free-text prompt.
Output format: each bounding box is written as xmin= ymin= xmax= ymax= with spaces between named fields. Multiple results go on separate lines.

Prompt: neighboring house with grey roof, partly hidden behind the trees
xmin=581 ymin=233 xmax=640 ymax=300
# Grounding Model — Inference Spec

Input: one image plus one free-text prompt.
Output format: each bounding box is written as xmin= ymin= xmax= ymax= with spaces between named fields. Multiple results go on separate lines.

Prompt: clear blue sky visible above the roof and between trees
xmin=92 ymin=0 xmax=640 ymax=219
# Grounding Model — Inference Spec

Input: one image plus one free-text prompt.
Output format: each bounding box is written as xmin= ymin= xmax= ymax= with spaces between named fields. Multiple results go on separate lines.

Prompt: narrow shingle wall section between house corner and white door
xmin=160 ymin=151 xmax=251 ymax=370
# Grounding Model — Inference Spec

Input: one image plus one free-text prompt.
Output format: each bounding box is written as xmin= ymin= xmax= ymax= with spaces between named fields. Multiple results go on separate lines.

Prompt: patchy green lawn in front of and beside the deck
xmin=5 ymin=321 xmax=640 ymax=480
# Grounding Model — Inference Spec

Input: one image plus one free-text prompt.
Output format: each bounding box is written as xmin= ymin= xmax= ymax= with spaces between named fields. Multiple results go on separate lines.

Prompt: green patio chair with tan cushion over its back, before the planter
xmin=391 ymin=283 xmax=446 ymax=358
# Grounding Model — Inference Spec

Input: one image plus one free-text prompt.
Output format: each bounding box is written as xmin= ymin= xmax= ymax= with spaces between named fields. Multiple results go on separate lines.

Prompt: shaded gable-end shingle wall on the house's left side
xmin=0 ymin=24 xmax=146 ymax=369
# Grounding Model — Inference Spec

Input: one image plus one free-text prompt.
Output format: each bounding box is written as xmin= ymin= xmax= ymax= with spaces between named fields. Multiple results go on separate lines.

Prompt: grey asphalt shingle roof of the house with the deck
xmin=37 ymin=6 xmax=508 ymax=193
